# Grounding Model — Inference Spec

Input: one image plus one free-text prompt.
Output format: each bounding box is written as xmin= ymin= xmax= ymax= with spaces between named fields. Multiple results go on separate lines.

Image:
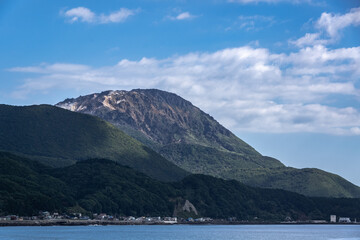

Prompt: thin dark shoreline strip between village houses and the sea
xmin=0 ymin=219 xmax=360 ymax=227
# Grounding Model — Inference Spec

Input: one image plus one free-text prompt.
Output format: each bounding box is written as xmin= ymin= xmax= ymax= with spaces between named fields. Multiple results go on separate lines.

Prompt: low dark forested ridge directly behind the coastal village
xmin=0 ymin=152 xmax=360 ymax=221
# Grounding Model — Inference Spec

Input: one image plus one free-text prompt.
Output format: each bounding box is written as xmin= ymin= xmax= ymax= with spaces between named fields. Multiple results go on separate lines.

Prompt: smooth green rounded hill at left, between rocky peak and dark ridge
xmin=0 ymin=105 xmax=188 ymax=181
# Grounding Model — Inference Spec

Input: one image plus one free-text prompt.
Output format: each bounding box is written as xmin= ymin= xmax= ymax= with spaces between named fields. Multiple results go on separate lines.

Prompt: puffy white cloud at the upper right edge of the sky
xmin=289 ymin=8 xmax=360 ymax=47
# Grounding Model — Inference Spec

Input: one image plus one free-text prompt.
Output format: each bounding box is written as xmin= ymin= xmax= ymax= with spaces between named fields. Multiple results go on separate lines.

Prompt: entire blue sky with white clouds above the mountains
xmin=0 ymin=0 xmax=360 ymax=185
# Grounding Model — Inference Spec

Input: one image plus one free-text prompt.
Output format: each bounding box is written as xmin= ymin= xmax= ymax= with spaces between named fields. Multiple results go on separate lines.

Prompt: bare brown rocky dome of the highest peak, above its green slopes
xmin=56 ymin=89 xmax=260 ymax=155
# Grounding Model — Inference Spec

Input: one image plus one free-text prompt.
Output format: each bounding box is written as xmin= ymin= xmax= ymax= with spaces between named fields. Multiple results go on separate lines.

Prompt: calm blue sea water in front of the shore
xmin=0 ymin=225 xmax=360 ymax=240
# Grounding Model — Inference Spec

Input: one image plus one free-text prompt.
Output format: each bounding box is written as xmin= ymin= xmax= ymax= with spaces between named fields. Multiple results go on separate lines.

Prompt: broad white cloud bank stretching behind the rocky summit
xmin=10 ymin=46 xmax=360 ymax=135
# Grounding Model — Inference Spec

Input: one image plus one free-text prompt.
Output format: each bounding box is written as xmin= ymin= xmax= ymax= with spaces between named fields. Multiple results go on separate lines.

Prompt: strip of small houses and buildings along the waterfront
xmin=0 ymin=211 xmax=360 ymax=226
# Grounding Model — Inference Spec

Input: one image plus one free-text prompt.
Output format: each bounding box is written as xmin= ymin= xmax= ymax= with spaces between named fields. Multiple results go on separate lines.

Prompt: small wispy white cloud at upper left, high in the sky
xmin=61 ymin=7 xmax=138 ymax=24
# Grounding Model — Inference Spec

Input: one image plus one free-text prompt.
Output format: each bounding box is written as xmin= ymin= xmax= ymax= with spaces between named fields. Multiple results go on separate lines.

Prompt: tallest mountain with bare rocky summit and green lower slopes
xmin=56 ymin=89 xmax=360 ymax=197
